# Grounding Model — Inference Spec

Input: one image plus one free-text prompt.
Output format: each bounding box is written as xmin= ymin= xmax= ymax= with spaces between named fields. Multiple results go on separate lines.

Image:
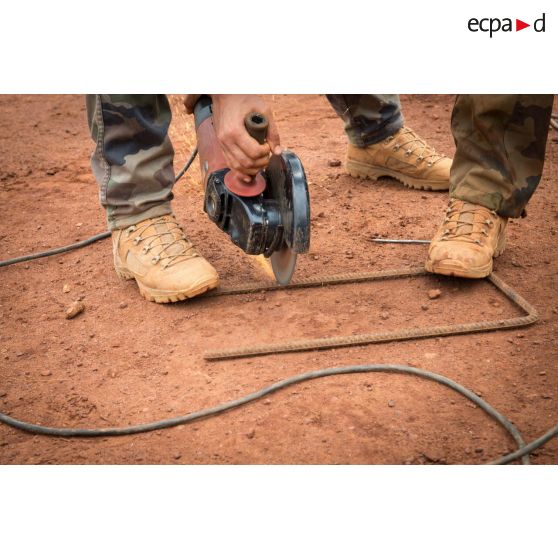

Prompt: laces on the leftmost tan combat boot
xmin=127 ymin=215 xmax=198 ymax=269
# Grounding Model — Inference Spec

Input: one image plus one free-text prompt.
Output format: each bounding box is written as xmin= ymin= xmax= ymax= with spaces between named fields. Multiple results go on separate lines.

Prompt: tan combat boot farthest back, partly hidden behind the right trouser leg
xmin=346 ymin=127 xmax=452 ymax=190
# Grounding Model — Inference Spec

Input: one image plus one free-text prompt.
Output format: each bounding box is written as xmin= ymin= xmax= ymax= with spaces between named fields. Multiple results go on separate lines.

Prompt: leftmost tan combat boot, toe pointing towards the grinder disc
xmin=112 ymin=215 xmax=219 ymax=303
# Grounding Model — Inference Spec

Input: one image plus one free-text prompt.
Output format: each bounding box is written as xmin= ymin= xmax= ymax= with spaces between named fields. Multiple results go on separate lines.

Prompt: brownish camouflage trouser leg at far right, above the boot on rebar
xmin=450 ymin=95 xmax=553 ymax=217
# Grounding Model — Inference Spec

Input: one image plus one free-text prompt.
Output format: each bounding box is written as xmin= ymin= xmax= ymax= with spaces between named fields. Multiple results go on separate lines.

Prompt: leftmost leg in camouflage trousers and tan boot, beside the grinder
xmin=87 ymin=95 xmax=219 ymax=302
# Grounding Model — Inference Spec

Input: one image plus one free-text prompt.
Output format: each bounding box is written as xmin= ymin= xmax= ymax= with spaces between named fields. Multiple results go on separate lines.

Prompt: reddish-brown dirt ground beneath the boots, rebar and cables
xmin=0 ymin=95 xmax=558 ymax=464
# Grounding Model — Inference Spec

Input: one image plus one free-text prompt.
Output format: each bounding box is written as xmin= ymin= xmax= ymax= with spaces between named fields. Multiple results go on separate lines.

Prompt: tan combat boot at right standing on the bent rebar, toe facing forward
xmin=425 ymin=199 xmax=508 ymax=279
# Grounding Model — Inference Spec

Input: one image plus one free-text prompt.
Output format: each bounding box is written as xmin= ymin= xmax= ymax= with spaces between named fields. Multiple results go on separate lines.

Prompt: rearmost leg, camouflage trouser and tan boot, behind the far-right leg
xmin=327 ymin=95 xmax=451 ymax=190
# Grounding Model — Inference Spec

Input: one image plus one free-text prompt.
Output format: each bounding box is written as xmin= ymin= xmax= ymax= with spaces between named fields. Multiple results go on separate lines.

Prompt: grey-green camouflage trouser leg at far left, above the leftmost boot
xmin=87 ymin=95 xmax=174 ymax=230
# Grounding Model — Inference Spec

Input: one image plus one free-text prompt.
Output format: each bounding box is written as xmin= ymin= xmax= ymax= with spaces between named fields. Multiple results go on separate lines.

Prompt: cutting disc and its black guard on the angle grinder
xmin=264 ymin=151 xmax=310 ymax=285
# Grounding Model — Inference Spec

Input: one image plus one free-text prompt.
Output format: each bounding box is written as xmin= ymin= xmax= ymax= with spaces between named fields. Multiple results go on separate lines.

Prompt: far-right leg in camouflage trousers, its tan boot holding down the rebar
xmin=426 ymin=95 xmax=553 ymax=278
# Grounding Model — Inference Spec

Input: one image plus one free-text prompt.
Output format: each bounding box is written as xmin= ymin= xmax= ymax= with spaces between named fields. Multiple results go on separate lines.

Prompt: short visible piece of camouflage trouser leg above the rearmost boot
xmin=326 ymin=95 xmax=403 ymax=147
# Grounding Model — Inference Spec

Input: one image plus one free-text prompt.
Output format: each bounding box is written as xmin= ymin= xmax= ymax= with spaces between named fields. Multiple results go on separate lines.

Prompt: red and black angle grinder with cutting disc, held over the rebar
xmin=194 ymin=95 xmax=310 ymax=285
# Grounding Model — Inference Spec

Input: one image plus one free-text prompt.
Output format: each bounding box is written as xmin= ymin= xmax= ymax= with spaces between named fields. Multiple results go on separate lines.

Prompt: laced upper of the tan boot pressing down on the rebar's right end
xmin=440 ymin=200 xmax=497 ymax=245
